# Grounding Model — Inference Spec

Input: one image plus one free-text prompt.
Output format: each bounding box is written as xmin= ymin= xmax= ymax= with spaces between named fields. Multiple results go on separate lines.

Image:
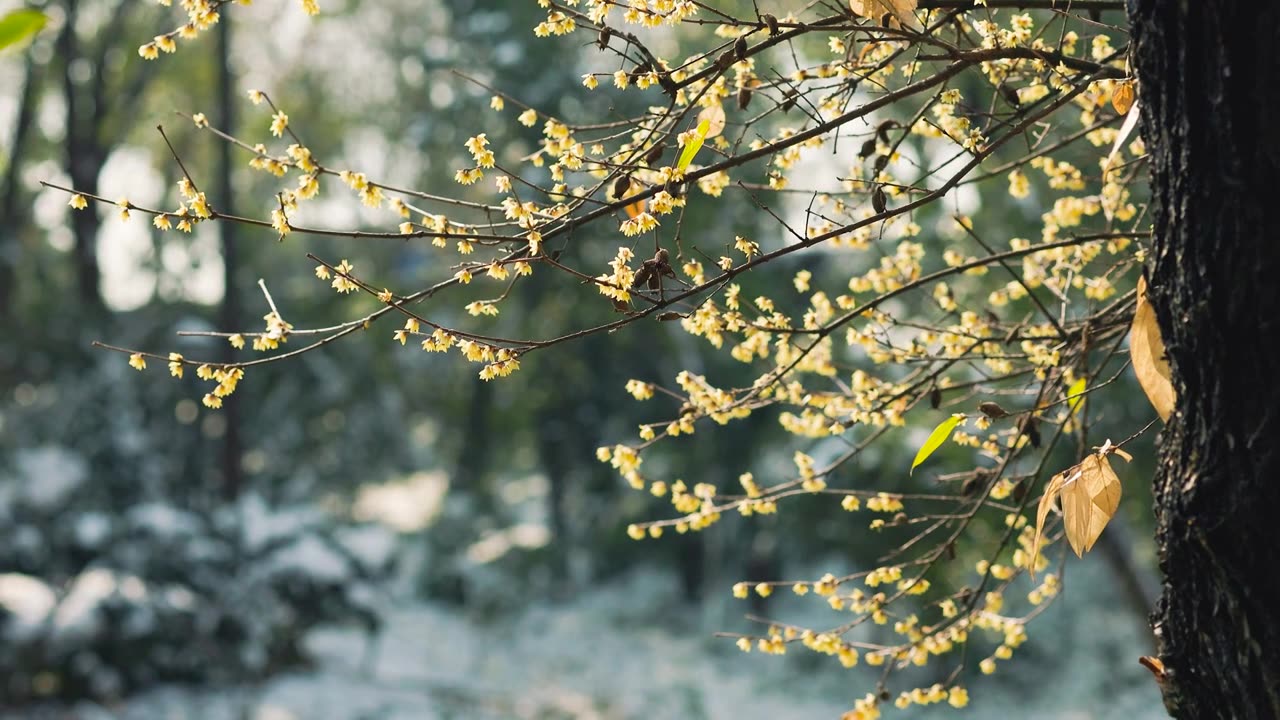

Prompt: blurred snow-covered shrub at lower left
xmin=0 ymin=447 xmax=396 ymax=707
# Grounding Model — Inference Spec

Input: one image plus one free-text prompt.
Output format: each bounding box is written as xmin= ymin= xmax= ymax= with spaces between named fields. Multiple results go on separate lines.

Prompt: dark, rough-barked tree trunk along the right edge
xmin=1129 ymin=0 xmax=1280 ymax=719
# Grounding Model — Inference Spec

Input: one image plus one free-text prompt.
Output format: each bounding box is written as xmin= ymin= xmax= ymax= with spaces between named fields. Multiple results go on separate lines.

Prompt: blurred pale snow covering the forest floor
xmin=12 ymin=560 xmax=1165 ymax=720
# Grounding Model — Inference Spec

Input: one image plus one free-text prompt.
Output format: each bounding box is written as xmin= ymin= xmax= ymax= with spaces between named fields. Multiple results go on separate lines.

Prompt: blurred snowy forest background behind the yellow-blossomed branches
xmin=0 ymin=0 xmax=1164 ymax=720
